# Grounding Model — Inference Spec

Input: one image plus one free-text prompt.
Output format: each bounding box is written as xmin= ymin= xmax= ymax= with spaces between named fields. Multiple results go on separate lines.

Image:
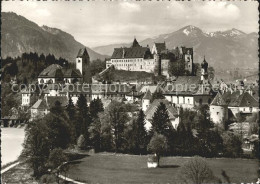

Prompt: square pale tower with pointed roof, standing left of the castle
xmin=76 ymin=48 xmax=91 ymax=84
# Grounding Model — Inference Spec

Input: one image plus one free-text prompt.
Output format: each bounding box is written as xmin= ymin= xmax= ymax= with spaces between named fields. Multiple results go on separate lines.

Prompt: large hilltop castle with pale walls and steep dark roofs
xmin=106 ymin=39 xmax=194 ymax=77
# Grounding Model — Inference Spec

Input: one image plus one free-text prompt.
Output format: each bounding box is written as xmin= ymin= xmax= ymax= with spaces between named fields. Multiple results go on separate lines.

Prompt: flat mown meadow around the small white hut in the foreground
xmin=65 ymin=154 xmax=258 ymax=184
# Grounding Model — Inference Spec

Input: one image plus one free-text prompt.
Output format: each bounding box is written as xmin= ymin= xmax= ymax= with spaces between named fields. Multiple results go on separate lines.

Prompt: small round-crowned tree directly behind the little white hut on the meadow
xmin=148 ymin=133 xmax=168 ymax=166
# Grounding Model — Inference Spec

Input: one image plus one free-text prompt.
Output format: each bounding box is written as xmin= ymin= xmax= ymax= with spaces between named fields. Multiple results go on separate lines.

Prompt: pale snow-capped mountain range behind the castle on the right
xmin=92 ymin=25 xmax=258 ymax=69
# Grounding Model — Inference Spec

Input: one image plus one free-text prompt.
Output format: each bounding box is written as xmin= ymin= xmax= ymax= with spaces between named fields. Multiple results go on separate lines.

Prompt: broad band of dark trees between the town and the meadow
xmin=19 ymin=95 xmax=254 ymax=176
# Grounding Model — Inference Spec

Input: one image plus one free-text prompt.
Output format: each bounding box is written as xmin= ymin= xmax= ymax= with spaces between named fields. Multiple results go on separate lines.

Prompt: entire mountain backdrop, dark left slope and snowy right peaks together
xmin=1 ymin=12 xmax=259 ymax=69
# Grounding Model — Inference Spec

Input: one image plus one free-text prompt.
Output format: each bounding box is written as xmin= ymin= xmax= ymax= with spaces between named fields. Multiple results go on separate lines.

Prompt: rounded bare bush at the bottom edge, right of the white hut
xmin=178 ymin=156 xmax=215 ymax=184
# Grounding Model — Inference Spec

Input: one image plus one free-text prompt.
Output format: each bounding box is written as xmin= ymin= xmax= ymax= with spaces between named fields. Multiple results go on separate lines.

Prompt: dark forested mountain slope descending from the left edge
xmin=1 ymin=12 xmax=107 ymax=62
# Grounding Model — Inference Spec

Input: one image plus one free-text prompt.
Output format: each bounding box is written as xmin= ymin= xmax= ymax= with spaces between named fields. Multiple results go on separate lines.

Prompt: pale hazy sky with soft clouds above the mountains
xmin=2 ymin=0 xmax=258 ymax=47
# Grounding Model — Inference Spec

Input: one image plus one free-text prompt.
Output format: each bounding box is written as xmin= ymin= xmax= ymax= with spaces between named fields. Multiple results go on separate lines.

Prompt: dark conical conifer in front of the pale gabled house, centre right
xmin=151 ymin=102 xmax=172 ymax=137
